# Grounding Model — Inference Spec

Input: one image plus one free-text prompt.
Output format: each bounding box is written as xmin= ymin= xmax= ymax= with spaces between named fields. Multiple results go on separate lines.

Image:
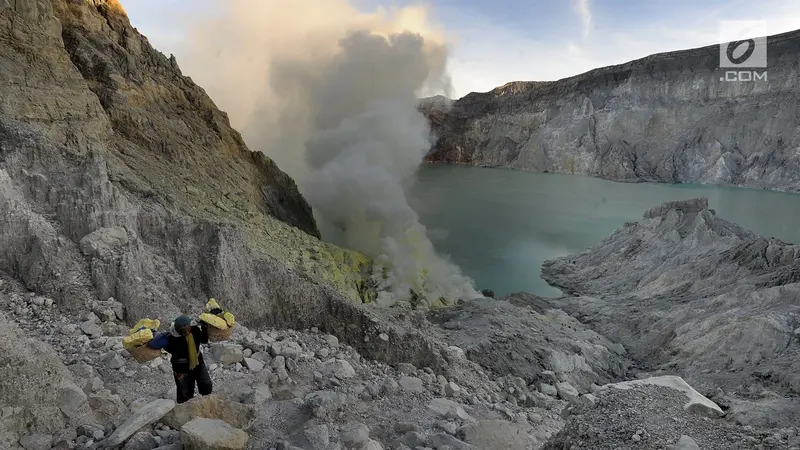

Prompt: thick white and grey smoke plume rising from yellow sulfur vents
xmin=179 ymin=0 xmax=477 ymax=304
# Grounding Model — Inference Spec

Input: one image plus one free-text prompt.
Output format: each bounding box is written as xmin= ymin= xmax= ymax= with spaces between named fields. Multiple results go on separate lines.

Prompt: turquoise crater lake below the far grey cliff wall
xmin=411 ymin=164 xmax=800 ymax=296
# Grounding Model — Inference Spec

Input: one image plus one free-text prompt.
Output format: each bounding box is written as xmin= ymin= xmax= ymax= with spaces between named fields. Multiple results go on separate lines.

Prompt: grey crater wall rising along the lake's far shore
xmin=421 ymin=32 xmax=800 ymax=191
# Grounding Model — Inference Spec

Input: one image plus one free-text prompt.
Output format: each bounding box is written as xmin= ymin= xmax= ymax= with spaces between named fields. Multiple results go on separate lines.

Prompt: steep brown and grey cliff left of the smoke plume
xmin=0 ymin=0 xmax=369 ymax=322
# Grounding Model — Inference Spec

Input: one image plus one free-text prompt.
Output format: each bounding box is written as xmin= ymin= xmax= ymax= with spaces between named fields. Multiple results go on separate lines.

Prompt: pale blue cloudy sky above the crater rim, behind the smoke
xmin=122 ymin=0 xmax=800 ymax=98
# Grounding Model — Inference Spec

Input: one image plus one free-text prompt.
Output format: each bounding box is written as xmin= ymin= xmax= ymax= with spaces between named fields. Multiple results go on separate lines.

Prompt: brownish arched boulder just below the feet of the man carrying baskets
xmin=162 ymin=394 xmax=256 ymax=430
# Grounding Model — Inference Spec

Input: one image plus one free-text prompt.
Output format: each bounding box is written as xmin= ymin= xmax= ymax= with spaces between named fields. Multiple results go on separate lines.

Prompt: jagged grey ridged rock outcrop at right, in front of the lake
xmin=542 ymin=198 xmax=800 ymax=425
